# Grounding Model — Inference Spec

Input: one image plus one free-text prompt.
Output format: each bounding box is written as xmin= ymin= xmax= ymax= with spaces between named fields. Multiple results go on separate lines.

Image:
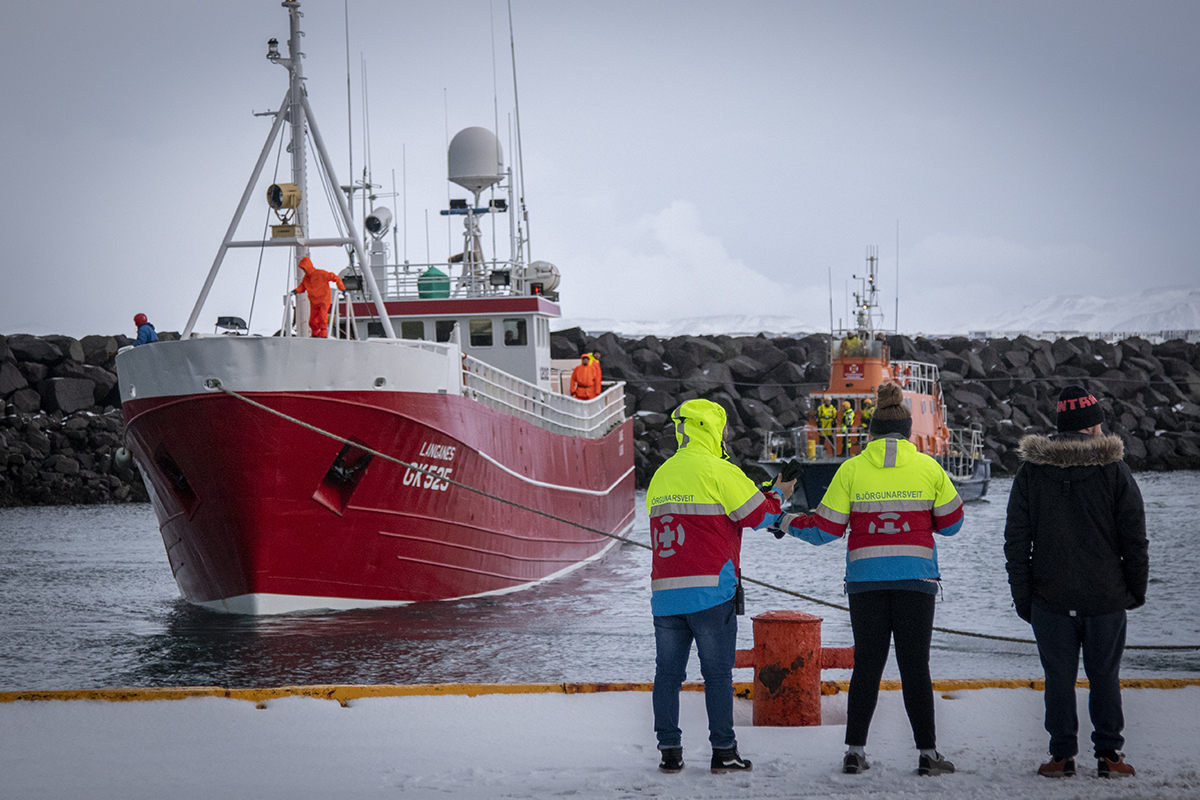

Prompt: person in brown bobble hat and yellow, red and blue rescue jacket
xmin=782 ymin=381 xmax=962 ymax=775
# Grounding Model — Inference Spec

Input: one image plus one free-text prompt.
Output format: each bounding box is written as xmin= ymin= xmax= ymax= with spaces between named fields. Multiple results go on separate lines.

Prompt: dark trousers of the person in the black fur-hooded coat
xmin=1033 ymin=603 xmax=1126 ymax=758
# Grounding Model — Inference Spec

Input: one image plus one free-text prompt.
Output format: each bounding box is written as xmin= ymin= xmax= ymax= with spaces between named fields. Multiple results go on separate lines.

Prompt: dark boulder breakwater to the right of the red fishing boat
xmin=551 ymin=329 xmax=1200 ymax=488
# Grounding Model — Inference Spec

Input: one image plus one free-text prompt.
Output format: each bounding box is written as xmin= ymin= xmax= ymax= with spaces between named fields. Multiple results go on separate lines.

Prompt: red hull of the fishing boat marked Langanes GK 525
xmin=124 ymin=392 xmax=634 ymax=610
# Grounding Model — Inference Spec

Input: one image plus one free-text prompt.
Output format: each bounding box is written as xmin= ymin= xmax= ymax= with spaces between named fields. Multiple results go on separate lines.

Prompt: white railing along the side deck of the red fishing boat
xmin=462 ymin=355 xmax=625 ymax=439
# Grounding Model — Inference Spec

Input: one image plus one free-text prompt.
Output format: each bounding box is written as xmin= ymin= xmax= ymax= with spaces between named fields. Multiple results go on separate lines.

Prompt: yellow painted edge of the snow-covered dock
xmin=0 ymin=678 xmax=1200 ymax=706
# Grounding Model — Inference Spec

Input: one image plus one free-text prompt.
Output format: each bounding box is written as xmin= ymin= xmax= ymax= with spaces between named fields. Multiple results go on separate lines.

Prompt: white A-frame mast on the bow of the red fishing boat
xmin=182 ymin=0 xmax=396 ymax=339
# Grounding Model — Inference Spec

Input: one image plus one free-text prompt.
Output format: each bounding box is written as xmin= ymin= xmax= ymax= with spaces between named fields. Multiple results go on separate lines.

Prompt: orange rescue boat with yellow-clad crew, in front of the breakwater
xmin=758 ymin=248 xmax=991 ymax=510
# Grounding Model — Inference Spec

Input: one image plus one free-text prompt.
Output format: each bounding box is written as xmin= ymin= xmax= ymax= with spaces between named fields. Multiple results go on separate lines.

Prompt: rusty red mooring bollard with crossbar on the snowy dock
xmin=734 ymin=610 xmax=854 ymax=726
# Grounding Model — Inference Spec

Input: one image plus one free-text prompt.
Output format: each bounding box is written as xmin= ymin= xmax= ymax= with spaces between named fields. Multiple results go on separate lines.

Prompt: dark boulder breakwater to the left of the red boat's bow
xmin=0 ymin=333 xmax=168 ymax=507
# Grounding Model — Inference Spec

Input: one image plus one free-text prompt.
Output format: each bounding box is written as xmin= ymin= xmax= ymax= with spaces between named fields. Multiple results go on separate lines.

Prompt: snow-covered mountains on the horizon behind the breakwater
xmin=553 ymin=287 xmax=1200 ymax=338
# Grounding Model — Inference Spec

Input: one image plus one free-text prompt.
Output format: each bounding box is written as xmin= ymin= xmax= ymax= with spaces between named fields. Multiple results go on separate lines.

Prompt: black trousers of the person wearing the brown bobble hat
xmin=846 ymin=589 xmax=937 ymax=750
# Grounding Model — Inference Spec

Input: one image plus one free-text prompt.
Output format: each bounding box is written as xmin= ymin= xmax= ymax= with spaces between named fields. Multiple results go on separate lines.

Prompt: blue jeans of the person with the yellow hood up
xmin=653 ymin=600 xmax=738 ymax=750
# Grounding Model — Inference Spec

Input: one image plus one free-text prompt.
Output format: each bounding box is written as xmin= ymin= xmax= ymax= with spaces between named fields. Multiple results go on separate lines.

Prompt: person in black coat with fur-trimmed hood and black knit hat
xmin=1004 ymin=386 xmax=1150 ymax=777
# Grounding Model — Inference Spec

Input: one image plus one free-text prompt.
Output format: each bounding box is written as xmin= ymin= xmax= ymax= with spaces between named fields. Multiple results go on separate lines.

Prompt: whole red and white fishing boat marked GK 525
xmin=118 ymin=2 xmax=634 ymax=614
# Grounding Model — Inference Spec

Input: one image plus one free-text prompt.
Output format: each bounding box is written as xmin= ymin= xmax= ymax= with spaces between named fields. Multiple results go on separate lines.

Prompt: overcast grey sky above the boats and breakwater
xmin=0 ymin=0 xmax=1200 ymax=336
